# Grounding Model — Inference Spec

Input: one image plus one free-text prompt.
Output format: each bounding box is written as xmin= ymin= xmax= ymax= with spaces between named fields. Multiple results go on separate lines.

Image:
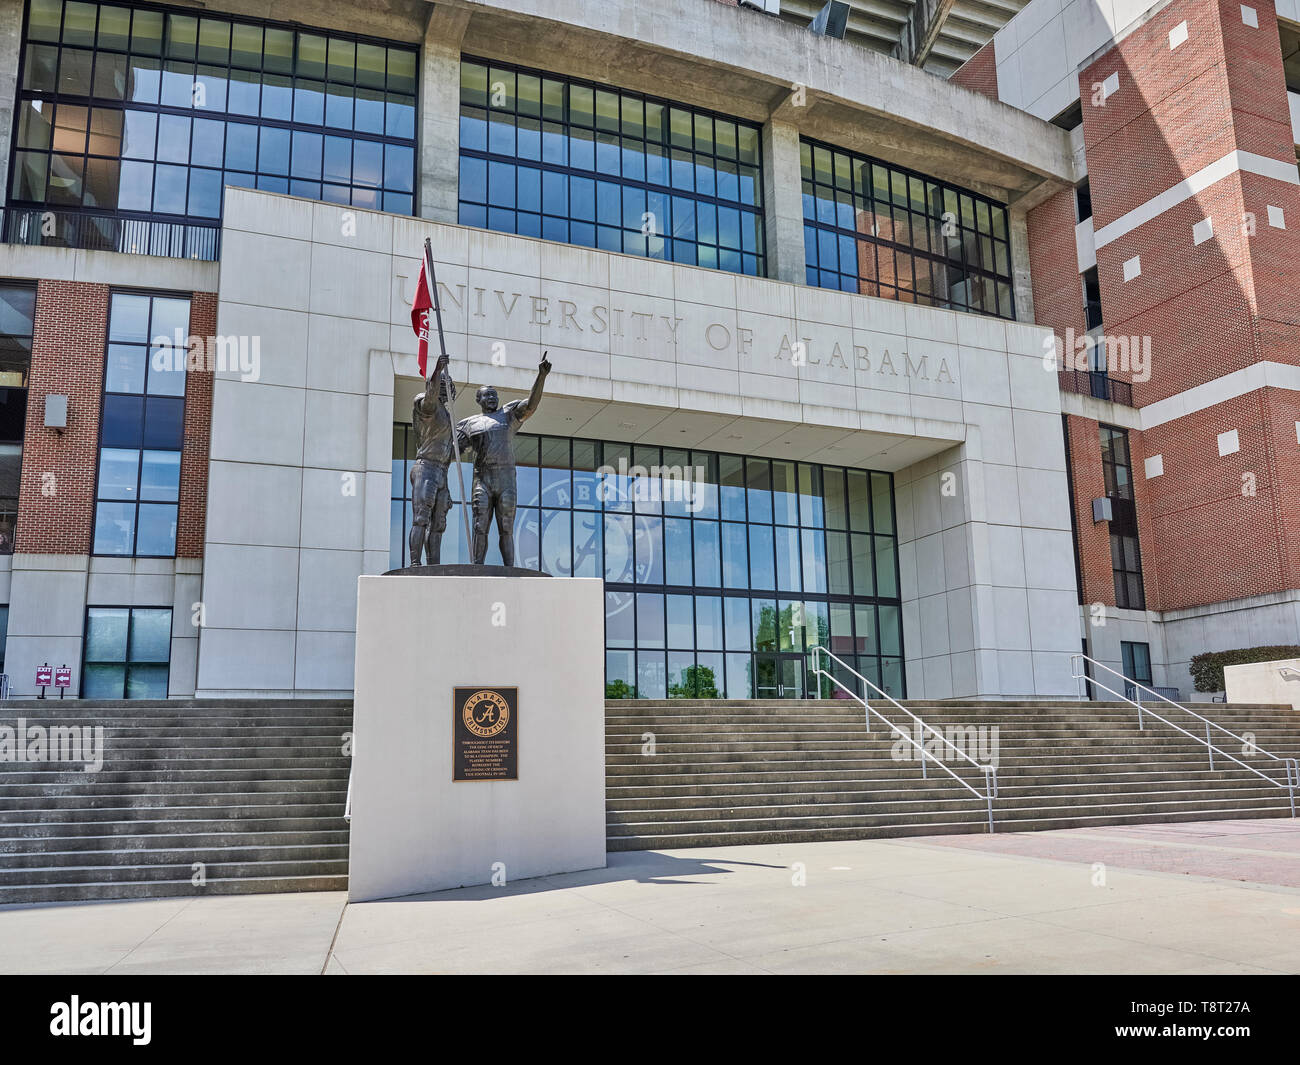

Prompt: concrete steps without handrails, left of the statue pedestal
xmin=0 ymin=700 xmax=352 ymax=905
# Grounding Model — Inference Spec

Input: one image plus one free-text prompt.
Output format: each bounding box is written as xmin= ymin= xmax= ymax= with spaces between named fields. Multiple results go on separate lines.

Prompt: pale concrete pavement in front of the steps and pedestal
xmin=0 ymin=819 xmax=1300 ymax=974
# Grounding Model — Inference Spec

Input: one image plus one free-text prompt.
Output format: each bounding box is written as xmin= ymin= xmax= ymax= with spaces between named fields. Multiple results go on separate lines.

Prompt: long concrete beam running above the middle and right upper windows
xmin=442 ymin=0 xmax=1073 ymax=196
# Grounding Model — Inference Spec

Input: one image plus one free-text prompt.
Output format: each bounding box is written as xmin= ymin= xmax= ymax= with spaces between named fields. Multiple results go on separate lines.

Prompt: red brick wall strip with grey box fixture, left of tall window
xmin=14 ymin=281 xmax=108 ymax=555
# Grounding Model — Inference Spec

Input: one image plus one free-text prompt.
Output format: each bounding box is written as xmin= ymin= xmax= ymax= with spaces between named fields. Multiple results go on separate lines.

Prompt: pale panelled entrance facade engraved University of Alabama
xmin=198 ymin=190 xmax=1078 ymax=697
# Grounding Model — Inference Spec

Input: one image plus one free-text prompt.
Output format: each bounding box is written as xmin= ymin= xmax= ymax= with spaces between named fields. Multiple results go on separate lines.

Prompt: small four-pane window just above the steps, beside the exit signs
xmin=81 ymin=606 xmax=172 ymax=698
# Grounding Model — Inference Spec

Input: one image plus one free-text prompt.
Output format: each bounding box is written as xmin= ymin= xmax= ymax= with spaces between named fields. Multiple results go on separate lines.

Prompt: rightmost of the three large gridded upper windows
xmin=800 ymin=133 xmax=1015 ymax=319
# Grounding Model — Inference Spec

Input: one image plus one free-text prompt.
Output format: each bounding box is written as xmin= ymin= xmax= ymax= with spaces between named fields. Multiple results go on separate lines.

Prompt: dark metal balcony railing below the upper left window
xmin=0 ymin=207 xmax=221 ymax=261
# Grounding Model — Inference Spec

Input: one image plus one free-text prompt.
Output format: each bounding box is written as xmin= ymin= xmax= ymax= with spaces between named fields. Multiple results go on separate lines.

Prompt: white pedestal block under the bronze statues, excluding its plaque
xmin=348 ymin=575 xmax=605 ymax=901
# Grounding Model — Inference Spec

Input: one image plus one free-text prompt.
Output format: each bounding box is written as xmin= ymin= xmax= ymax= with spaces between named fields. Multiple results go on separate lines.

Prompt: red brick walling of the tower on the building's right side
xmin=1055 ymin=0 xmax=1300 ymax=610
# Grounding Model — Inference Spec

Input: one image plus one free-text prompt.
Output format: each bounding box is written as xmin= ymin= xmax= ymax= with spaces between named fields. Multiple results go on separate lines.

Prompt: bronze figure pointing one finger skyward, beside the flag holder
xmin=454 ymin=351 xmax=551 ymax=566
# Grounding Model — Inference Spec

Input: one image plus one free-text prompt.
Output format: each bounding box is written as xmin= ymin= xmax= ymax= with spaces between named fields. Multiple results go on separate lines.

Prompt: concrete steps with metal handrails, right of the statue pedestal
xmin=606 ymin=700 xmax=1300 ymax=850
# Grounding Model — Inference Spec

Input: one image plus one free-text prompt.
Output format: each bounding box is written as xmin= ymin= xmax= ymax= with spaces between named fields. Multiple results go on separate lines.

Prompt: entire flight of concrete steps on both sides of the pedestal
xmin=0 ymin=700 xmax=1300 ymax=905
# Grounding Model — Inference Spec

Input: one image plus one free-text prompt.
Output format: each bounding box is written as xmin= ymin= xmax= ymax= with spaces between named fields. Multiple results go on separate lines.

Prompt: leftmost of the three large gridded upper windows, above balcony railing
xmin=8 ymin=0 xmax=416 ymax=259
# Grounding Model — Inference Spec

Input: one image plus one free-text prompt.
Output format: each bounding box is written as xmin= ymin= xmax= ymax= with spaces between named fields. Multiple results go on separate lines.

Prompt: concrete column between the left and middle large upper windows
xmin=418 ymin=8 xmax=469 ymax=224
